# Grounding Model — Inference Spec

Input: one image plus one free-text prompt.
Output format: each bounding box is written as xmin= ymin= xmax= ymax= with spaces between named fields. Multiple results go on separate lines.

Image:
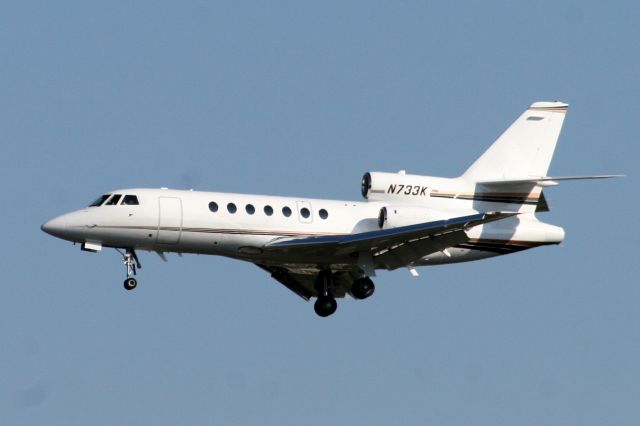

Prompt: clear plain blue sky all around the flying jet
xmin=0 ymin=0 xmax=640 ymax=425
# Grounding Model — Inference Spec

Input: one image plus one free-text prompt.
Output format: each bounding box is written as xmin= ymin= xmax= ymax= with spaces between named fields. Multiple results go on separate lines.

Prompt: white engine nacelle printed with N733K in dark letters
xmin=361 ymin=172 xmax=434 ymax=203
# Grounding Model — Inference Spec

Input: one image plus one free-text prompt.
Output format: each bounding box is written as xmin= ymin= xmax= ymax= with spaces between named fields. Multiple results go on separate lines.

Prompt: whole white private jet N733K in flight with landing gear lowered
xmin=42 ymin=102 xmax=619 ymax=317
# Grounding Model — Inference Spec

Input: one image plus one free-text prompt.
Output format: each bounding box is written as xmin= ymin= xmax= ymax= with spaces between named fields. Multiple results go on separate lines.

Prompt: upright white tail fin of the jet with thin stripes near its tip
xmin=462 ymin=102 xmax=568 ymax=182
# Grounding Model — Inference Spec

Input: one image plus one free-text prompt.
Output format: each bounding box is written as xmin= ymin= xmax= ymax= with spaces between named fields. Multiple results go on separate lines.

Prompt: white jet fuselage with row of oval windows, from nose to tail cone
xmin=43 ymin=178 xmax=564 ymax=267
